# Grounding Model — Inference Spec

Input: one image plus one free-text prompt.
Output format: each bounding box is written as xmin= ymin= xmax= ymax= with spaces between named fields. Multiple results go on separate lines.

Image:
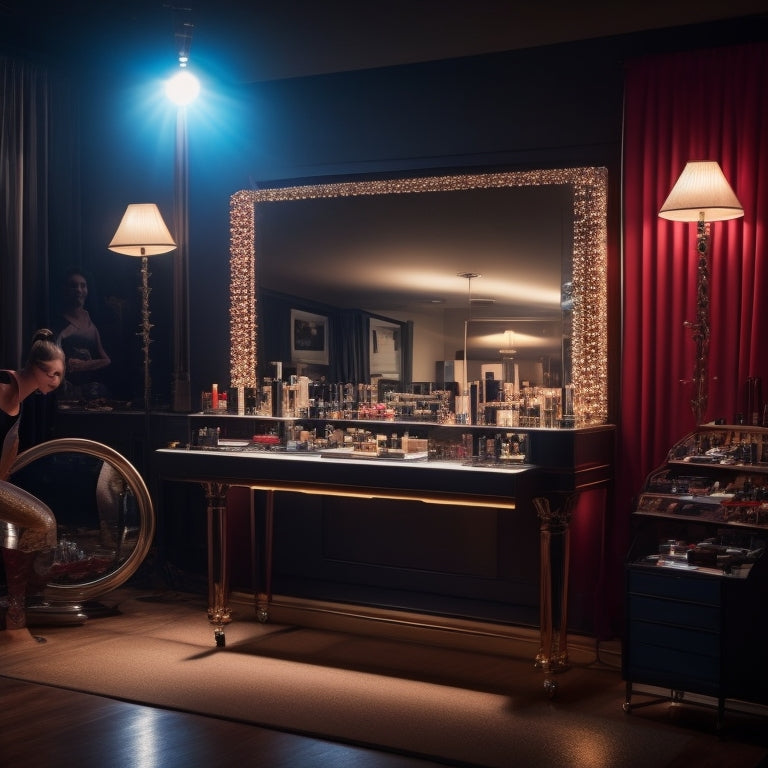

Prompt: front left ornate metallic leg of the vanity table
xmin=202 ymin=482 xmax=232 ymax=648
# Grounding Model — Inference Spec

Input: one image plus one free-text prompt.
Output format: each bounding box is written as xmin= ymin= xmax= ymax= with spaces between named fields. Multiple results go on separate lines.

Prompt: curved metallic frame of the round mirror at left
xmin=11 ymin=437 xmax=155 ymax=602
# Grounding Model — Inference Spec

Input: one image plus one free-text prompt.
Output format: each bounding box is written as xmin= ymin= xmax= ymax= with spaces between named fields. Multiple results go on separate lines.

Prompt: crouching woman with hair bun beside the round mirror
xmin=0 ymin=329 xmax=65 ymax=641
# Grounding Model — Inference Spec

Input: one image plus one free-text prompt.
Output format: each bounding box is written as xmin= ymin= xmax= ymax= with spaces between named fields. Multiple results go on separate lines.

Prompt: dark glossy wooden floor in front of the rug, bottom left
xmin=0 ymin=676 xmax=456 ymax=768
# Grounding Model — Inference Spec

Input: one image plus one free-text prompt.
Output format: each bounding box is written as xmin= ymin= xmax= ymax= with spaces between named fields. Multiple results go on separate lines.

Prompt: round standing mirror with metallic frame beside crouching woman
xmin=9 ymin=438 xmax=155 ymax=603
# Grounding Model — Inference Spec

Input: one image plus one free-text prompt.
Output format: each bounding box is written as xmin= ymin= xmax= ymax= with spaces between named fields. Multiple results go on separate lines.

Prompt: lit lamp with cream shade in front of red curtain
xmin=659 ymin=160 xmax=744 ymax=426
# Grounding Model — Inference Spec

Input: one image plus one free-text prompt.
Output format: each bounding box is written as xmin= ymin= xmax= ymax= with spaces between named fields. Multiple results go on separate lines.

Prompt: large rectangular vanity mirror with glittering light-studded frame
xmin=230 ymin=167 xmax=607 ymax=426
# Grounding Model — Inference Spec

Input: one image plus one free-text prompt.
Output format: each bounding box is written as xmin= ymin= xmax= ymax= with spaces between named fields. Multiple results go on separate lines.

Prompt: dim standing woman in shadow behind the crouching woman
xmin=56 ymin=269 xmax=111 ymax=400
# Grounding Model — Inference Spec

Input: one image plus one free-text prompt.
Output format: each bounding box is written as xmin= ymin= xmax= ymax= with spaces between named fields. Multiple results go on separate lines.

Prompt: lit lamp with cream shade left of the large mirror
xmin=107 ymin=203 xmax=176 ymax=414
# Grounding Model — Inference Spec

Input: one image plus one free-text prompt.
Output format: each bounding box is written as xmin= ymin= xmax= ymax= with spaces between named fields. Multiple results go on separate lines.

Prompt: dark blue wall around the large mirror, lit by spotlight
xmin=69 ymin=16 xmax=764 ymax=405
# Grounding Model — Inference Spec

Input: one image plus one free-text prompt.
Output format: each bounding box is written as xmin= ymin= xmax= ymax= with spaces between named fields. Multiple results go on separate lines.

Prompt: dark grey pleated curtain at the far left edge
xmin=0 ymin=56 xmax=82 ymax=367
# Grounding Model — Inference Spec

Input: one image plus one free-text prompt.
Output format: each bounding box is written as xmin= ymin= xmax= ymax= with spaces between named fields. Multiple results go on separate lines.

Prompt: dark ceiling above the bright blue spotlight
xmin=0 ymin=0 xmax=765 ymax=82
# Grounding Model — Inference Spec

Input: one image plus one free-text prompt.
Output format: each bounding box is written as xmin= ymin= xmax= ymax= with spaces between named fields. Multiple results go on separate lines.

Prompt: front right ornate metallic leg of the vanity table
xmin=533 ymin=494 xmax=578 ymax=697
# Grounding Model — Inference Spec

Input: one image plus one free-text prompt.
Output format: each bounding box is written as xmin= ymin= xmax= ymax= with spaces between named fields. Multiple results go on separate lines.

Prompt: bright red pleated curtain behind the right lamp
xmin=612 ymin=43 xmax=768 ymax=632
